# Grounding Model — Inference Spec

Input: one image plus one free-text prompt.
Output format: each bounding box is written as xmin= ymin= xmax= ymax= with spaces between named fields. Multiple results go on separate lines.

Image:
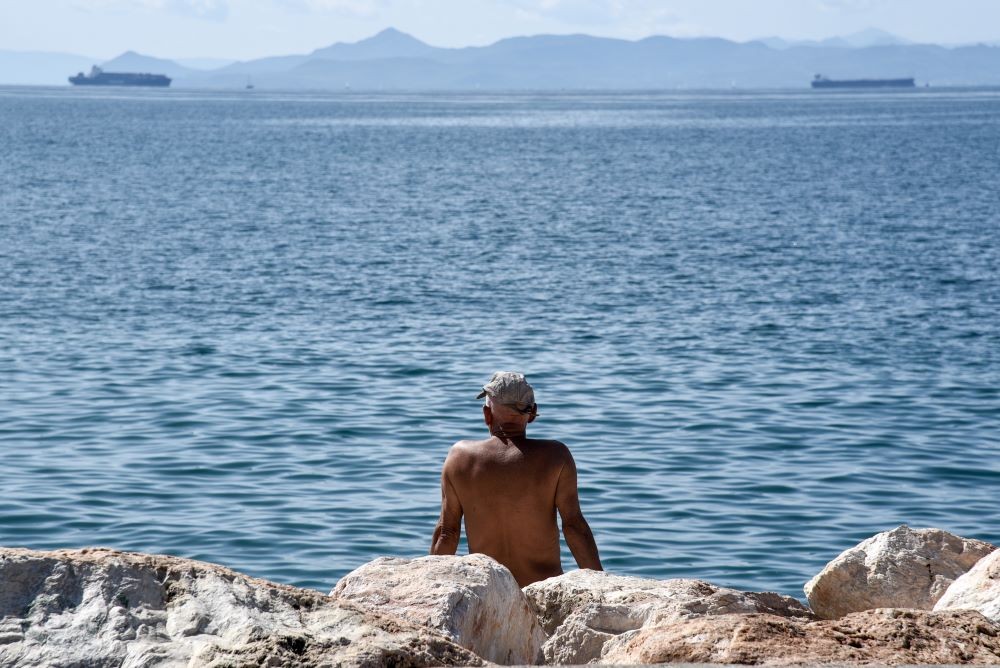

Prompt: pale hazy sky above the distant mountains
xmin=0 ymin=0 xmax=1000 ymax=59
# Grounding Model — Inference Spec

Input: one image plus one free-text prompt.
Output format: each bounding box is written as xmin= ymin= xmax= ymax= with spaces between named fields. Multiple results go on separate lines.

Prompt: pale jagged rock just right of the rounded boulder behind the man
xmin=524 ymin=570 xmax=811 ymax=664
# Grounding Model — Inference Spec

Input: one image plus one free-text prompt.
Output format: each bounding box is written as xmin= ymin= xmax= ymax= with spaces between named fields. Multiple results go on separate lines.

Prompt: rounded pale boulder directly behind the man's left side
xmin=330 ymin=554 xmax=546 ymax=665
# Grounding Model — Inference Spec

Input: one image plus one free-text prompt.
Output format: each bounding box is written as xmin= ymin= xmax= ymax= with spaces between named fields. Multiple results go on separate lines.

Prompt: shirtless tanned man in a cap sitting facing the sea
xmin=431 ymin=371 xmax=603 ymax=587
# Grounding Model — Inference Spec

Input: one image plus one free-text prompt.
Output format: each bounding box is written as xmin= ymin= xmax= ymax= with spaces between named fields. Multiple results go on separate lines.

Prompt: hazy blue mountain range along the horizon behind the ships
xmin=0 ymin=28 xmax=1000 ymax=90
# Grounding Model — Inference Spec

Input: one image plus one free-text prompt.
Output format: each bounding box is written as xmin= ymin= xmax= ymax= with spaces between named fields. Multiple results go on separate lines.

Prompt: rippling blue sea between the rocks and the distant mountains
xmin=0 ymin=88 xmax=1000 ymax=597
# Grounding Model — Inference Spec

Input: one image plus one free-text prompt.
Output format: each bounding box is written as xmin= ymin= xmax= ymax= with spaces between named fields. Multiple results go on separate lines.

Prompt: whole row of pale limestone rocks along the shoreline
xmin=0 ymin=526 xmax=1000 ymax=668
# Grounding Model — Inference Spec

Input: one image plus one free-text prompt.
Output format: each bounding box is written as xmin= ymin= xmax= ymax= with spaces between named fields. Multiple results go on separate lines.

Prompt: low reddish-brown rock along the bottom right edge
xmin=601 ymin=609 xmax=1000 ymax=666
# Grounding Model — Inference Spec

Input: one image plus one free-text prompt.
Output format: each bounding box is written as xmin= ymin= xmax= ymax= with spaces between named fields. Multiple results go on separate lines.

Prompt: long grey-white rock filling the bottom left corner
xmin=0 ymin=548 xmax=482 ymax=668
